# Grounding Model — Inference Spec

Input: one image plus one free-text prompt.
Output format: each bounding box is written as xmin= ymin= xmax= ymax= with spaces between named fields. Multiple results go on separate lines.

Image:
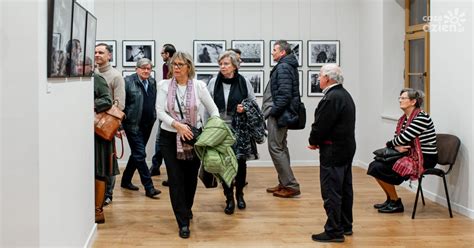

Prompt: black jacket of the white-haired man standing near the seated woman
xmin=309 ymin=85 xmax=356 ymax=166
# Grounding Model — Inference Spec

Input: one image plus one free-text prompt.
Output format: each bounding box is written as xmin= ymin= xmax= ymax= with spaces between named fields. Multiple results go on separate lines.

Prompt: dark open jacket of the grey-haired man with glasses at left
xmin=122 ymin=73 xmax=156 ymax=130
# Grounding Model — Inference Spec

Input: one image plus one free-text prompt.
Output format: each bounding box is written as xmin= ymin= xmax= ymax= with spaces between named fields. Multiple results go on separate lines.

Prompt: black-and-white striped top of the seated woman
xmin=388 ymin=111 xmax=438 ymax=154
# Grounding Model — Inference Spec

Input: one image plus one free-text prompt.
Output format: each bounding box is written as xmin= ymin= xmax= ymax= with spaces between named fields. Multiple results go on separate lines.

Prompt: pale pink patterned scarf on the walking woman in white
xmin=167 ymin=77 xmax=197 ymax=160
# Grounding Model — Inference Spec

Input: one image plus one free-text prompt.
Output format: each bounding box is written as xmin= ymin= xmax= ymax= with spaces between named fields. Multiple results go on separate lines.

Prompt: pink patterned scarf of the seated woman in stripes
xmin=392 ymin=108 xmax=424 ymax=180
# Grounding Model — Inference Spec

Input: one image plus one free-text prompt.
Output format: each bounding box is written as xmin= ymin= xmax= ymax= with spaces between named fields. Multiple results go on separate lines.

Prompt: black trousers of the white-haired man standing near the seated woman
xmin=319 ymin=163 xmax=354 ymax=237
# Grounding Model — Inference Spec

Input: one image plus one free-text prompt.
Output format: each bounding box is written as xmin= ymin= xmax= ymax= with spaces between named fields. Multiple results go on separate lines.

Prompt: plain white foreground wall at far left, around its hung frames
xmin=0 ymin=0 xmax=95 ymax=247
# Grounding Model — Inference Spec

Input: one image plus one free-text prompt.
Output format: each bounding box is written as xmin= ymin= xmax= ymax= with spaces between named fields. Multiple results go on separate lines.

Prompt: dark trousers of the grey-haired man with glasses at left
xmin=122 ymin=123 xmax=153 ymax=191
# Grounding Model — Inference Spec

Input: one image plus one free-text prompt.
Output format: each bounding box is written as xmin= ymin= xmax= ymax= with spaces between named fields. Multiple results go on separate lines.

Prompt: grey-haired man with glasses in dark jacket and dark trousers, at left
xmin=121 ymin=58 xmax=161 ymax=198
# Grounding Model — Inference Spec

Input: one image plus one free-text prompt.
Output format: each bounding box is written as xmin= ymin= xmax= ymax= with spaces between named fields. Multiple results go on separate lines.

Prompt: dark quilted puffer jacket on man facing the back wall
xmin=270 ymin=54 xmax=300 ymax=127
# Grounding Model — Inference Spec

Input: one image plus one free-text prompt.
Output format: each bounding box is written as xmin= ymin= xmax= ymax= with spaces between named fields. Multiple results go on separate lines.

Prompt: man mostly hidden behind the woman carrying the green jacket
xmin=150 ymin=44 xmax=176 ymax=186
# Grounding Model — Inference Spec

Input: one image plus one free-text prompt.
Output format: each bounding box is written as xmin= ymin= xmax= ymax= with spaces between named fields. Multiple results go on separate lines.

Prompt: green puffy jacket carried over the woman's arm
xmin=194 ymin=116 xmax=238 ymax=187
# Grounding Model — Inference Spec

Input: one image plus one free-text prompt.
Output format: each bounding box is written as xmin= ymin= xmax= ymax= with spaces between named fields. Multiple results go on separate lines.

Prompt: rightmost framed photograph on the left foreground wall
xmin=83 ymin=12 xmax=97 ymax=77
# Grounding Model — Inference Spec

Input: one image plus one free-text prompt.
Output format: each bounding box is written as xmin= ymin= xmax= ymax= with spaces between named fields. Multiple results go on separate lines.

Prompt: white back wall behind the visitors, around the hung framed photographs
xmin=95 ymin=0 xmax=359 ymax=165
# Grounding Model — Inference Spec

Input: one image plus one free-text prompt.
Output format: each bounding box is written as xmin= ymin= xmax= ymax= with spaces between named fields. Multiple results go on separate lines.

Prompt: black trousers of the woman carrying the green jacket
xmin=160 ymin=129 xmax=201 ymax=227
